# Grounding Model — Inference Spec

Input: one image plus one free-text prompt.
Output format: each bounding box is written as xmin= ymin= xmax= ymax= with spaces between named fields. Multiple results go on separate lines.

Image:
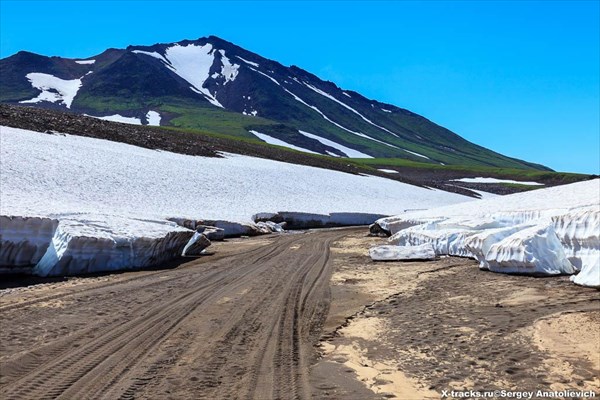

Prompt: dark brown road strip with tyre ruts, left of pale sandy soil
xmin=0 ymin=229 xmax=353 ymax=399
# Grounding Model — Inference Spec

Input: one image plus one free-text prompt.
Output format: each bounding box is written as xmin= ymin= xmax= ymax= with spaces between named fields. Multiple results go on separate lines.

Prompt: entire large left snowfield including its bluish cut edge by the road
xmin=0 ymin=126 xmax=472 ymax=275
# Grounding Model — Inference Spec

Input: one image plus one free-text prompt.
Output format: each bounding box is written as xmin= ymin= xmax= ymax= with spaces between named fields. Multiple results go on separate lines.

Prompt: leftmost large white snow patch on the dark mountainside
xmin=19 ymin=72 xmax=81 ymax=108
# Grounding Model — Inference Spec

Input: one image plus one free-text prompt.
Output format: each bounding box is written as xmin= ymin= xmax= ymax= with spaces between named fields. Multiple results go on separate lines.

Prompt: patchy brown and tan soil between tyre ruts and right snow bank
xmin=311 ymin=234 xmax=600 ymax=399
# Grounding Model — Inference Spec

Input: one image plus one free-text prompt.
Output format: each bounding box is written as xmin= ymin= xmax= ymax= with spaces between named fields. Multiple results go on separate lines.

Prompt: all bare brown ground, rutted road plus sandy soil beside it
xmin=0 ymin=229 xmax=600 ymax=400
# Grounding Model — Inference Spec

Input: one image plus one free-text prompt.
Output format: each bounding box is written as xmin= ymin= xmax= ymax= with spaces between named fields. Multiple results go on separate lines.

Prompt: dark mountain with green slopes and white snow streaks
xmin=0 ymin=36 xmax=544 ymax=169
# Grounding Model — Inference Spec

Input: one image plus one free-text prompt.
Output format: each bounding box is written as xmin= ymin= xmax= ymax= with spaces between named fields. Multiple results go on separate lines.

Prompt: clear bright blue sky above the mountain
xmin=0 ymin=0 xmax=600 ymax=174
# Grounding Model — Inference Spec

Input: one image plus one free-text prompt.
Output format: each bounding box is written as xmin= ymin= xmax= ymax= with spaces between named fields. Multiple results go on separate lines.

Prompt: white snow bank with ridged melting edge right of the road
xmin=371 ymin=179 xmax=600 ymax=287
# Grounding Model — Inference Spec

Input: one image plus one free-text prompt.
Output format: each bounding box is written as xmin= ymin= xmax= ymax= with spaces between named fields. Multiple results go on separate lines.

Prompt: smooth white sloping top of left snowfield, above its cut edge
xmin=0 ymin=127 xmax=478 ymax=223
